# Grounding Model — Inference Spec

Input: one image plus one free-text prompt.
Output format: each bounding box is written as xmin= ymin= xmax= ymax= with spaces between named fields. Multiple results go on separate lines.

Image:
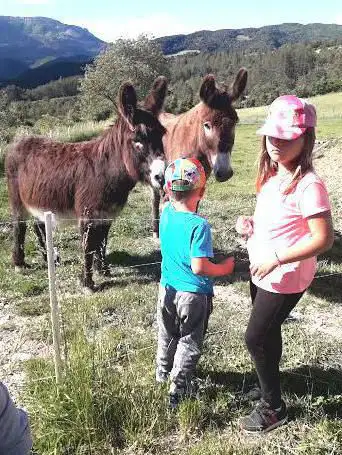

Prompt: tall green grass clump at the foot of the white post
xmin=26 ymin=301 xmax=173 ymax=454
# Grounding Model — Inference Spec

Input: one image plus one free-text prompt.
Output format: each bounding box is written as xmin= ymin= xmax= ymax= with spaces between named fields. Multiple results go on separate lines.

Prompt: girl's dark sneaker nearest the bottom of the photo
xmin=240 ymin=399 xmax=288 ymax=433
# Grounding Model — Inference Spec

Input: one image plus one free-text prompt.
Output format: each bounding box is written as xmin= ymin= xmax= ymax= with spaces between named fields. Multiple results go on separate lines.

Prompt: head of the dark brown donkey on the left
xmin=118 ymin=77 xmax=166 ymax=188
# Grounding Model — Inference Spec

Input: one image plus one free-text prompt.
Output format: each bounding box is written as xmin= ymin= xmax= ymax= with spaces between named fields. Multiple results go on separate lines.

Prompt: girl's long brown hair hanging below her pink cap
xmin=256 ymin=127 xmax=316 ymax=194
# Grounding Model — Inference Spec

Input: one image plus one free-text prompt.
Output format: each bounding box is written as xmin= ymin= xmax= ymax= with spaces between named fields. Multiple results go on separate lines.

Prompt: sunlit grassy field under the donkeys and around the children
xmin=0 ymin=93 xmax=342 ymax=455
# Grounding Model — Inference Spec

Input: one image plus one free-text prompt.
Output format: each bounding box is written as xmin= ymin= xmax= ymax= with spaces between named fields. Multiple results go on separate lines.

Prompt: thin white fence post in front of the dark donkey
xmin=44 ymin=212 xmax=62 ymax=384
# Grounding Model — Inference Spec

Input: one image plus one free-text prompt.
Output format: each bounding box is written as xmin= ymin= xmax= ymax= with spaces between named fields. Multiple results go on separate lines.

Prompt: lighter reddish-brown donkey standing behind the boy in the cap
xmin=147 ymin=68 xmax=247 ymax=239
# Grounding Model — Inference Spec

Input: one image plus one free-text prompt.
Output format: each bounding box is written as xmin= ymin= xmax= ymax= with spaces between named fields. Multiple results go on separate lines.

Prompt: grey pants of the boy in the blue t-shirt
xmin=157 ymin=286 xmax=212 ymax=389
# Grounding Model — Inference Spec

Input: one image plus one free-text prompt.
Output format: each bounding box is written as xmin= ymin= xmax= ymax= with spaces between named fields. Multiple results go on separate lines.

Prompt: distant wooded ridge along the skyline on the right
xmin=156 ymin=23 xmax=342 ymax=55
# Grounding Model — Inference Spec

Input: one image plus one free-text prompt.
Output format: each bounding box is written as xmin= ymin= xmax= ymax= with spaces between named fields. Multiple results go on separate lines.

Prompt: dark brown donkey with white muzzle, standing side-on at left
xmin=5 ymin=77 xmax=165 ymax=289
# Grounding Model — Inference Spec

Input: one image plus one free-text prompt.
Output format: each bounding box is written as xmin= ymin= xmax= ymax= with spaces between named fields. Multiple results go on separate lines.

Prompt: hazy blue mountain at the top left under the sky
xmin=0 ymin=16 xmax=106 ymax=79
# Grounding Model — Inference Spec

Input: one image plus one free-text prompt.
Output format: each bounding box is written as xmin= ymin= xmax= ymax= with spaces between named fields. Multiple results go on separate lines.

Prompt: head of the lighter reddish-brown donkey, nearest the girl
xmin=197 ymin=68 xmax=247 ymax=182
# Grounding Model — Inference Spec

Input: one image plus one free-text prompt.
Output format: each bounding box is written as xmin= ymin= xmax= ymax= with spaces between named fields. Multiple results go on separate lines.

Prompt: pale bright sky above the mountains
xmin=0 ymin=0 xmax=342 ymax=42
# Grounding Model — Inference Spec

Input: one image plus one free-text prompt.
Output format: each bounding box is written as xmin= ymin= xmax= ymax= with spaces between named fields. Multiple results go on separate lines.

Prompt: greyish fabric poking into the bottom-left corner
xmin=0 ymin=382 xmax=32 ymax=455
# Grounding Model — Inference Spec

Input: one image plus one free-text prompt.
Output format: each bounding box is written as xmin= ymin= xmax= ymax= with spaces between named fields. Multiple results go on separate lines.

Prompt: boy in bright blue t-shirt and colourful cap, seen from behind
xmin=156 ymin=158 xmax=234 ymax=408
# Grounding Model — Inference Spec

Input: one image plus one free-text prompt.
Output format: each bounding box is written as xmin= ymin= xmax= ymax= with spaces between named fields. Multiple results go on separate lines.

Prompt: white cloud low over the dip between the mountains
xmin=63 ymin=13 xmax=196 ymax=42
